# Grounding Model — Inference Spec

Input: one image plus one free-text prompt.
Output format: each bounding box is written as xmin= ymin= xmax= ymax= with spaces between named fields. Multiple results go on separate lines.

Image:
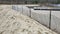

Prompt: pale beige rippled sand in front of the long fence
xmin=0 ymin=5 xmax=57 ymax=34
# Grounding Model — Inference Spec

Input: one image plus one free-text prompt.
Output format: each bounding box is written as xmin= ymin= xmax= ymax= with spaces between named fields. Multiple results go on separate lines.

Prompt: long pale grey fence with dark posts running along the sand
xmin=12 ymin=5 xmax=60 ymax=33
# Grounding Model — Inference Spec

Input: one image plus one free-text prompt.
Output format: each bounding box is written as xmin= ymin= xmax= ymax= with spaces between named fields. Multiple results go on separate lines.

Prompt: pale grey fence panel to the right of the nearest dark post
xmin=51 ymin=11 xmax=60 ymax=33
